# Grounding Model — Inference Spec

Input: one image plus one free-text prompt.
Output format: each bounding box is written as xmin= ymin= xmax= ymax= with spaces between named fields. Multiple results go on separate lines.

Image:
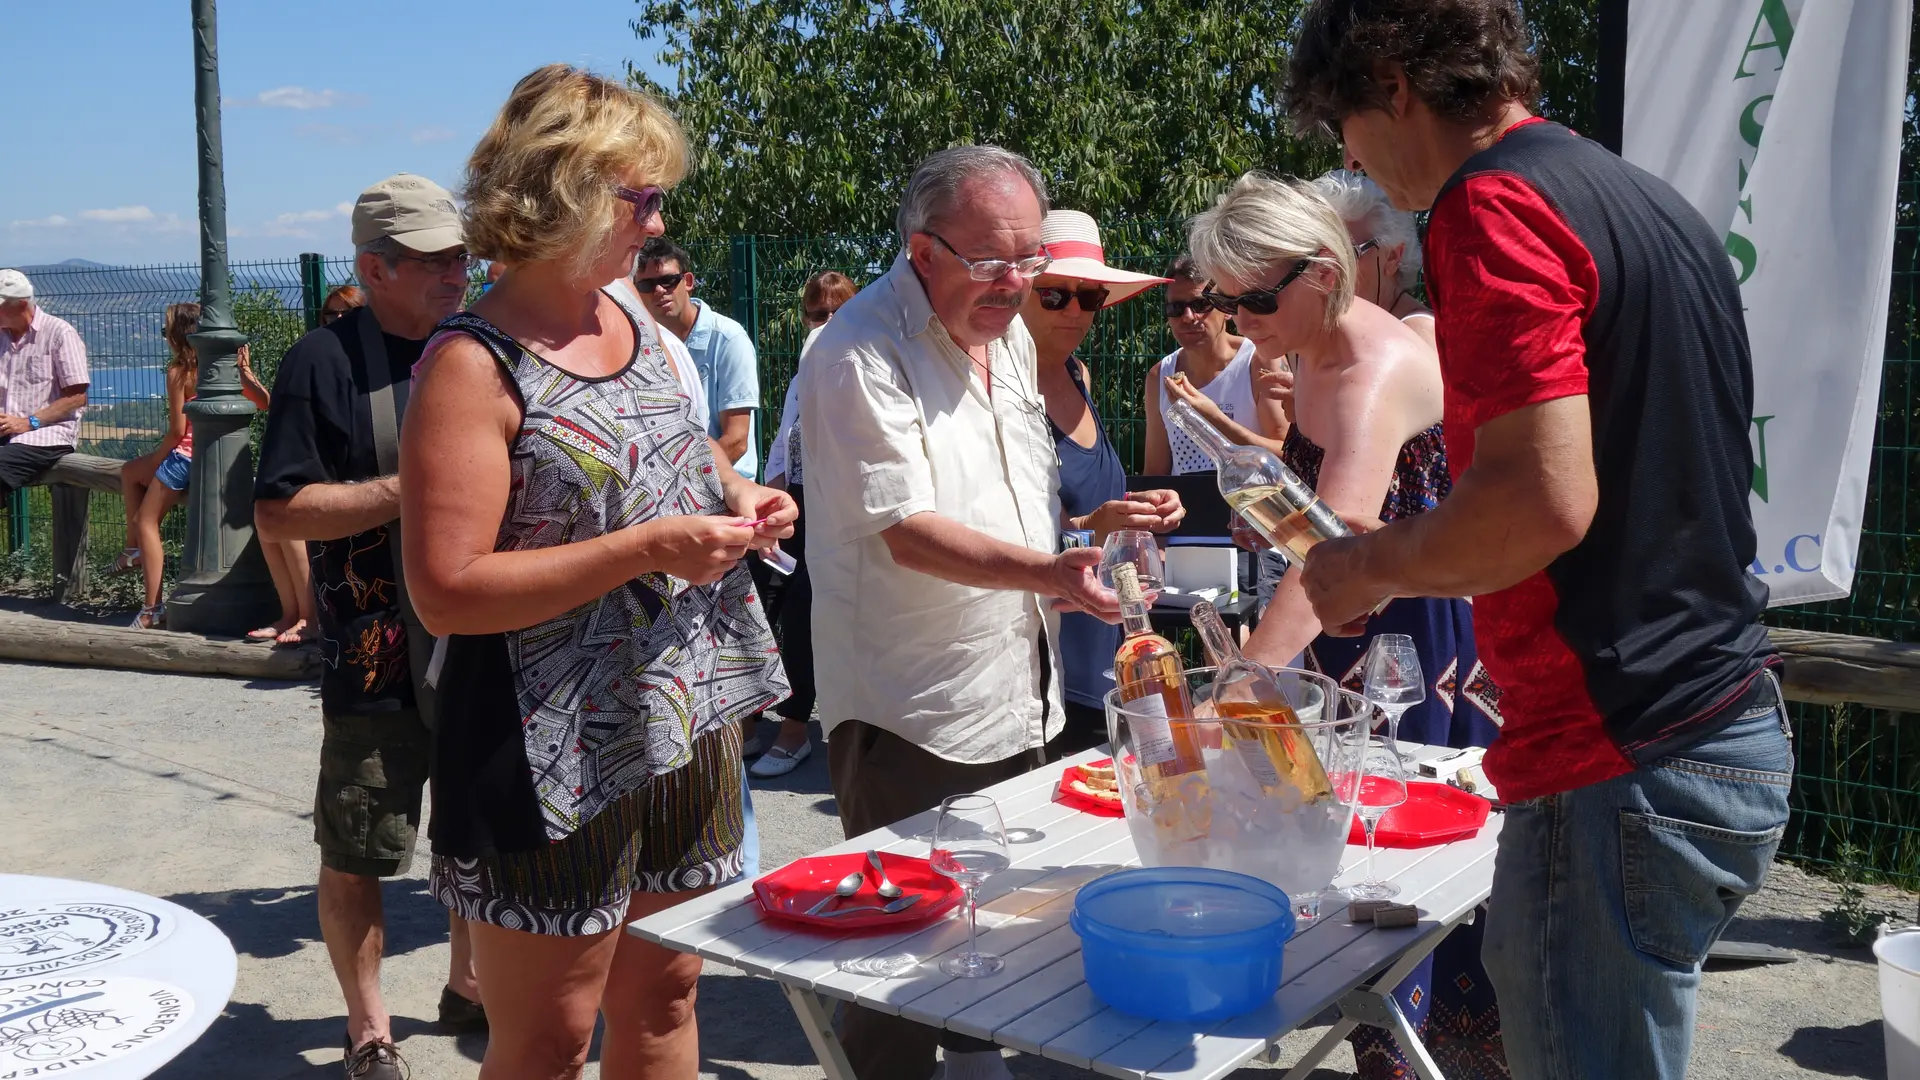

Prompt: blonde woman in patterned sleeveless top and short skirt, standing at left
xmin=399 ymin=65 xmax=799 ymax=1080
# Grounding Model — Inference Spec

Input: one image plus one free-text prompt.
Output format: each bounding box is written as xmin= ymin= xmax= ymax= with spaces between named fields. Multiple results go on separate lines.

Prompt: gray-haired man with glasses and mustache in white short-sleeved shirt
xmin=799 ymin=146 xmax=1117 ymax=1080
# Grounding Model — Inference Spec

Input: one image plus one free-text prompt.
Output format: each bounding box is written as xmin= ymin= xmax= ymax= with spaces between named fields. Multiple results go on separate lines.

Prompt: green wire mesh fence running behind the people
xmin=8 ymin=176 xmax=1920 ymax=882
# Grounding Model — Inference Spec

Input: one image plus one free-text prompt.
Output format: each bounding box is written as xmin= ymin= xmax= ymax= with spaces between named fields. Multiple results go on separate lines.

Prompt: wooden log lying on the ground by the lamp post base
xmin=0 ymin=611 xmax=321 ymax=682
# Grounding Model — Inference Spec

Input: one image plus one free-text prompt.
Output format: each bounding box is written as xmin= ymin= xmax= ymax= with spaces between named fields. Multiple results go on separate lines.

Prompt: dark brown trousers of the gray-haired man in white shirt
xmin=828 ymin=721 xmax=1058 ymax=1080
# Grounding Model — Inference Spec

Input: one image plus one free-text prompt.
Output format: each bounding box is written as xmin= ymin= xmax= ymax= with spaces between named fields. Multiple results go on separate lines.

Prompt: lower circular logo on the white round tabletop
xmin=0 ymin=978 xmax=194 ymax=1080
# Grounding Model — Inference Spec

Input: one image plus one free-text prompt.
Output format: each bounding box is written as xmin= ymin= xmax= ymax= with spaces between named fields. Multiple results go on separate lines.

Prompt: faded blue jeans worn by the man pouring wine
xmin=1482 ymin=687 xmax=1793 ymax=1080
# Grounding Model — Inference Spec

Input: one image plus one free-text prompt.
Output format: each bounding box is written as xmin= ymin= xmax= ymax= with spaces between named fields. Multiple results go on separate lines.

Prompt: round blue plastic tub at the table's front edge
xmin=1069 ymin=867 xmax=1294 ymax=1020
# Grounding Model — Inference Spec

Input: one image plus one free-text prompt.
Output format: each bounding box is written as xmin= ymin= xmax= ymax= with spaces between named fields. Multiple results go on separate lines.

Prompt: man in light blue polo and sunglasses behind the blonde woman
xmin=634 ymin=236 xmax=760 ymax=479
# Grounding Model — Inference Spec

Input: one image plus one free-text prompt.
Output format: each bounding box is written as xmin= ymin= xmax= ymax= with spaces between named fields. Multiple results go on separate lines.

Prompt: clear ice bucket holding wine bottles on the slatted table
xmin=1106 ymin=667 xmax=1373 ymax=903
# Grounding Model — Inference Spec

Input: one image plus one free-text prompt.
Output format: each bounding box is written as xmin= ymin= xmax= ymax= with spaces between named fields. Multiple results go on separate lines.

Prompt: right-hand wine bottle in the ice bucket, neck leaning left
xmin=1192 ymin=600 xmax=1332 ymax=803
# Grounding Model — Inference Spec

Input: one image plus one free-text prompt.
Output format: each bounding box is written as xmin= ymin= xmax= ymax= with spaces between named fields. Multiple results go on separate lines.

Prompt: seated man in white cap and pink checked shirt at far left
xmin=0 ymin=269 xmax=88 ymax=496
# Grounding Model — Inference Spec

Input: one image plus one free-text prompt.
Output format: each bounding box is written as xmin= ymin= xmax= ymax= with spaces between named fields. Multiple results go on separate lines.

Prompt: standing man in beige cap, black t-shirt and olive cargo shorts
xmin=253 ymin=173 xmax=484 ymax=1080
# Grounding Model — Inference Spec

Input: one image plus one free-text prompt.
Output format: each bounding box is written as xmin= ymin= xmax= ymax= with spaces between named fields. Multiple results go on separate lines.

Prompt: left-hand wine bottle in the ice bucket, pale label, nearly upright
xmin=1114 ymin=563 xmax=1206 ymax=778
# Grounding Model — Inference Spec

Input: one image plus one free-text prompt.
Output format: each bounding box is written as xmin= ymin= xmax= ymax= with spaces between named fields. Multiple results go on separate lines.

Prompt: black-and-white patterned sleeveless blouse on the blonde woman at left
xmin=434 ymin=290 xmax=787 ymax=855
